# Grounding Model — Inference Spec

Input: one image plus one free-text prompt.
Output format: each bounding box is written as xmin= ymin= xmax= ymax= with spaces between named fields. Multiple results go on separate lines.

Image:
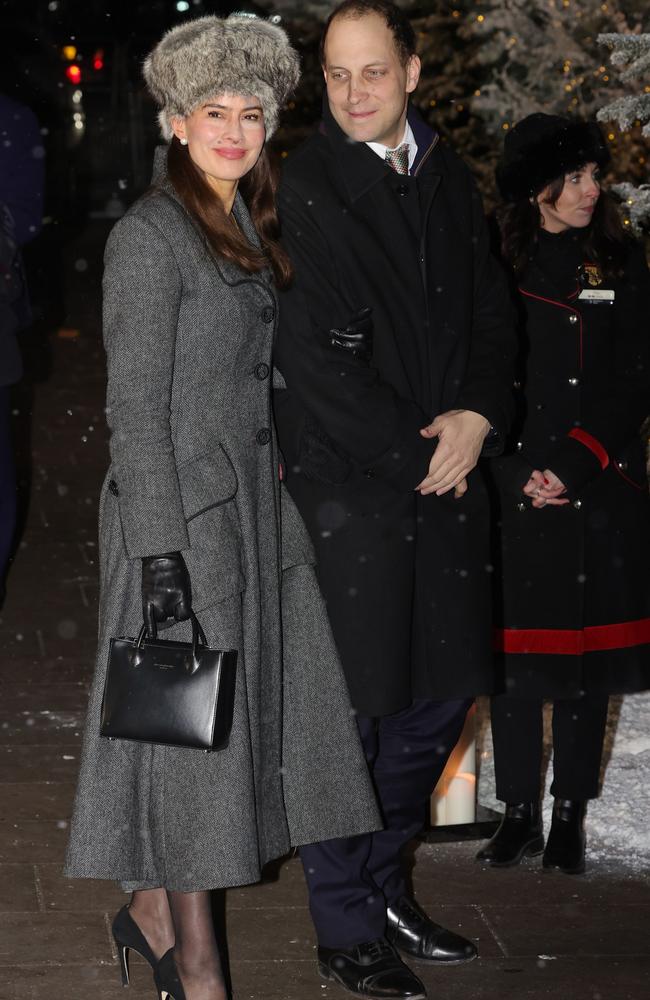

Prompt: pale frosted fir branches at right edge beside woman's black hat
xmin=598 ymin=33 xmax=650 ymax=235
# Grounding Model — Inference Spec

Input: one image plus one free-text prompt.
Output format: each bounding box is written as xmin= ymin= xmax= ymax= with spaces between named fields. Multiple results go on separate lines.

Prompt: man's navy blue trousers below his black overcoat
xmin=300 ymin=699 xmax=471 ymax=948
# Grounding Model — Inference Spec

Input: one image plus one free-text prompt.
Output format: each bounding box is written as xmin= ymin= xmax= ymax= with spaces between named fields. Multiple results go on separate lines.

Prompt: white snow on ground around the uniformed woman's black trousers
xmin=477 ymin=692 xmax=650 ymax=873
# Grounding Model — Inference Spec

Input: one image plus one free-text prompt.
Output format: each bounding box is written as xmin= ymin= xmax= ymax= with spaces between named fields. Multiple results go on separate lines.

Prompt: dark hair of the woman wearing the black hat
xmin=496 ymin=177 xmax=627 ymax=278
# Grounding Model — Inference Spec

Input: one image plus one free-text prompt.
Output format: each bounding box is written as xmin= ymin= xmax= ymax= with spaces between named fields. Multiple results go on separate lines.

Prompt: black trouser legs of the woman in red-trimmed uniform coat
xmin=491 ymin=694 xmax=609 ymax=802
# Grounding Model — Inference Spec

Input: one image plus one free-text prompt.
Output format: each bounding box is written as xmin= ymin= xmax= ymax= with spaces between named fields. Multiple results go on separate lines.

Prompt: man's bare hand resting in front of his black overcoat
xmin=416 ymin=410 xmax=490 ymax=497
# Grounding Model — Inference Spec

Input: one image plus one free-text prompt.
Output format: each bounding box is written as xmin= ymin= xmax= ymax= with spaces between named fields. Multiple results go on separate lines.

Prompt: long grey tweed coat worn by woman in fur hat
xmin=66 ymin=164 xmax=380 ymax=891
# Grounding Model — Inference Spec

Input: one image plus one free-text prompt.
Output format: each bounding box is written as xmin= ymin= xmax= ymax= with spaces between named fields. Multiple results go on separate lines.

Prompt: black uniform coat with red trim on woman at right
xmin=490 ymin=231 xmax=650 ymax=697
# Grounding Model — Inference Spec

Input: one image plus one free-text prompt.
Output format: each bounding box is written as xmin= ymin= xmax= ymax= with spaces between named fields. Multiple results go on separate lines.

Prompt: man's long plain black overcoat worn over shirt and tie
xmin=276 ymin=108 xmax=514 ymax=715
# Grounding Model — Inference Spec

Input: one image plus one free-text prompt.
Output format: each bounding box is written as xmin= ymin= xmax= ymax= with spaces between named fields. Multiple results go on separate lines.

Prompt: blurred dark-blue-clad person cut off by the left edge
xmin=0 ymin=93 xmax=44 ymax=605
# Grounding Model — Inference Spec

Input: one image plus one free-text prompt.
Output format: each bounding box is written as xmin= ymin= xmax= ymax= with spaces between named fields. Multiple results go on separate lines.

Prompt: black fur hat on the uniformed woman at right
xmin=496 ymin=113 xmax=610 ymax=201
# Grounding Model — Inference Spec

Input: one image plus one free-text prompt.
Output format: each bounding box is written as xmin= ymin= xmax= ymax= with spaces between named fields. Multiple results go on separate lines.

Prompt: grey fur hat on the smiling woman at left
xmin=143 ymin=14 xmax=300 ymax=142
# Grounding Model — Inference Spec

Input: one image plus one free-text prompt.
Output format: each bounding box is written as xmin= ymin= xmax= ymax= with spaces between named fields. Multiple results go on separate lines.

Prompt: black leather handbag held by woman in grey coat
xmin=99 ymin=614 xmax=237 ymax=752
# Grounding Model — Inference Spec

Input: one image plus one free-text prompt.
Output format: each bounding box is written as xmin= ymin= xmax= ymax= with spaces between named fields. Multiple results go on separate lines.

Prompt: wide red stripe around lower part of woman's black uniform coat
xmin=494 ymin=618 xmax=650 ymax=656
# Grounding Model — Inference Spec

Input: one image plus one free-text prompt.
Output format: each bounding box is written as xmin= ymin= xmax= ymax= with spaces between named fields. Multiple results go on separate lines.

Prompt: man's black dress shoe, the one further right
xmin=386 ymin=896 xmax=478 ymax=965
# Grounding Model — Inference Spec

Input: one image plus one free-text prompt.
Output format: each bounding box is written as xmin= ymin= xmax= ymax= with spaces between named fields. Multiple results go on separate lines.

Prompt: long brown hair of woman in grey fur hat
xmin=167 ymin=136 xmax=293 ymax=288
